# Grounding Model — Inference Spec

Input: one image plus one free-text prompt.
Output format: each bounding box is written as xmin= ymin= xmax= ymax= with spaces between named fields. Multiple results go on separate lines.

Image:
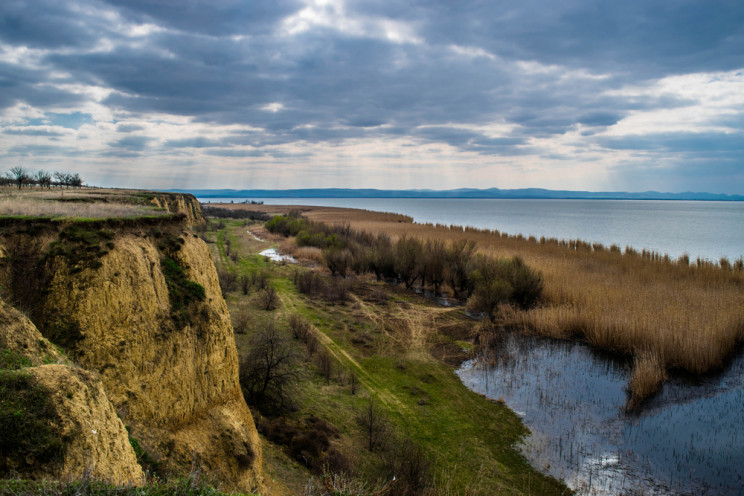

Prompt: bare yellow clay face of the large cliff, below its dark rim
xmin=38 ymin=233 xmax=261 ymax=490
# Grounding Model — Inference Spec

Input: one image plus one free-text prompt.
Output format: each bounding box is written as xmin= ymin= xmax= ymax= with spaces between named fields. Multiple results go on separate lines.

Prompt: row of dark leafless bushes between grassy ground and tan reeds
xmin=265 ymin=212 xmax=543 ymax=320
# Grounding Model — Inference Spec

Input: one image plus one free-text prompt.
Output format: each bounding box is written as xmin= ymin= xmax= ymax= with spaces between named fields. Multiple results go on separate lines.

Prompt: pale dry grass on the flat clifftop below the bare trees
xmin=0 ymin=189 xmax=168 ymax=218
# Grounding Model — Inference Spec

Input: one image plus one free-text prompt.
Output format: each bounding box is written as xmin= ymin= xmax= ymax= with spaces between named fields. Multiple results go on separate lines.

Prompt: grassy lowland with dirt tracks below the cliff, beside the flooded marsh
xmin=205 ymin=217 xmax=570 ymax=495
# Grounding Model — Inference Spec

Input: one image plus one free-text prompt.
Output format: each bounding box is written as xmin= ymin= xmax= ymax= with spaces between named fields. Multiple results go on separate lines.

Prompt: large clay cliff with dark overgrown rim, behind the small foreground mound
xmin=0 ymin=194 xmax=262 ymax=491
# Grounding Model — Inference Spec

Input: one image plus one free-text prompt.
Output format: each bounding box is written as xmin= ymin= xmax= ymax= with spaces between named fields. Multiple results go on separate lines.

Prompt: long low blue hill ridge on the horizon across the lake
xmin=174 ymin=188 xmax=744 ymax=201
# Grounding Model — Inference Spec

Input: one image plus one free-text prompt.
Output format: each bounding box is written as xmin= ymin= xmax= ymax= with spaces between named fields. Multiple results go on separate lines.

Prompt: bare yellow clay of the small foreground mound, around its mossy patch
xmin=0 ymin=300 xmax=144 ymax=485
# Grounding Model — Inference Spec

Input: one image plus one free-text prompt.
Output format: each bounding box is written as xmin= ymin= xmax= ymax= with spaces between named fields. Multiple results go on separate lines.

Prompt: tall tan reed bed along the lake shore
xmin=225 ymin=202 xmax=744 ymax=384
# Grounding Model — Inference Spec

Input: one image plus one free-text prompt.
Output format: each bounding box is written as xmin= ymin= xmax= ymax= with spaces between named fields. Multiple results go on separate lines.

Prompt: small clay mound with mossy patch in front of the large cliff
xmin=0 ymin=300 xmax=144 ymax=485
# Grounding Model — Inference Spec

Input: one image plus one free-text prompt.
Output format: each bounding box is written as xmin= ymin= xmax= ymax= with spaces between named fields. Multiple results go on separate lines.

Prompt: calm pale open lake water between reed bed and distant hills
xmin=204 ymin=198 xmax=744 ymax=261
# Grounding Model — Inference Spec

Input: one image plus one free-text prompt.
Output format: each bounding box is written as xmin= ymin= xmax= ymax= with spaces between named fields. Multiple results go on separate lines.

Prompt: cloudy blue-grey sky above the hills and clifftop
xmin=0 ymin=0 xmax=744 ymax=194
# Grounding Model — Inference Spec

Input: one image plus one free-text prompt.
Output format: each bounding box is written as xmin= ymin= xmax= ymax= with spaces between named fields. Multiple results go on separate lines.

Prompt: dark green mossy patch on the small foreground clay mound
xmin=0 ymin=370 xmax=63 ymax=477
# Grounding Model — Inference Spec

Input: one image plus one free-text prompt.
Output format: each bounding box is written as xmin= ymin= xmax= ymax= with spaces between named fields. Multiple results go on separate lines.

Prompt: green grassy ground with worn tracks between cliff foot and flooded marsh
xmin=209 ymin=221 xmax=567 ymax=494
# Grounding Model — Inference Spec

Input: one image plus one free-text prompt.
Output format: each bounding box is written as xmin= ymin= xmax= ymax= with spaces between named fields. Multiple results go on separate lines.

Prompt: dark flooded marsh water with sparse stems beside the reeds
xmin=458 ymin=335 xmax=744 ymax=495
